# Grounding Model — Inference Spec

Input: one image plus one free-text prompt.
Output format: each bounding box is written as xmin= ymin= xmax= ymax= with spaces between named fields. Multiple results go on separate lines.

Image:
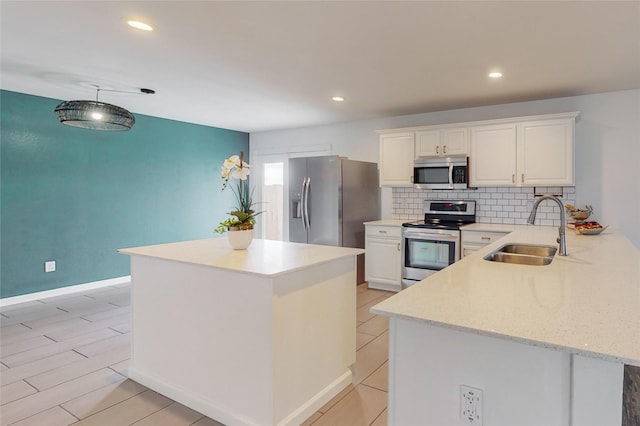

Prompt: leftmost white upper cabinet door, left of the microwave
xmin=380 ymin=133 xmax=414 ymax=186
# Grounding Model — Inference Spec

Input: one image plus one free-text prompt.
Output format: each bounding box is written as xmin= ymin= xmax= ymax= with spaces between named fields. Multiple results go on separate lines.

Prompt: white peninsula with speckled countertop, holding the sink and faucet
xmin=371 ymin=224 xmax=640 ymax=426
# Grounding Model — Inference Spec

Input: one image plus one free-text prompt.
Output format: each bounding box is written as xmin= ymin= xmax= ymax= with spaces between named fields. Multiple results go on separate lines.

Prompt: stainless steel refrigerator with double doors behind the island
xmin=289 ymin=155 xmax=380 ymax=248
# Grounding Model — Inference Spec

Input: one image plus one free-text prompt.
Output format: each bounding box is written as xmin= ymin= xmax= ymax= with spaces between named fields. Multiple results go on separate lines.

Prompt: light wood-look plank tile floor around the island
xmin=0 ymin=284 xmax=393 ymax=426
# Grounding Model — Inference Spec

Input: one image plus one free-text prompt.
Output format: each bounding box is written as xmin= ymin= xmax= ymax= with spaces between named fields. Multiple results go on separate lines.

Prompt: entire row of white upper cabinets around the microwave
xmin=378 ymin=112 xmax=580 ymax=186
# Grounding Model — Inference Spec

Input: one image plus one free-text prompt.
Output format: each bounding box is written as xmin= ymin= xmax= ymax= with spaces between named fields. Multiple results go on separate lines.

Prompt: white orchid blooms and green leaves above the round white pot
xmin=214 ymin=152 xmax=262 ymax=234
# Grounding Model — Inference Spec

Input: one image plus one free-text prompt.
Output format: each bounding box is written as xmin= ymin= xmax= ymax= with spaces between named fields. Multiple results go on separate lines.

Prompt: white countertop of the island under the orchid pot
xmin=118 ymin=237 xmax=364 ymax=277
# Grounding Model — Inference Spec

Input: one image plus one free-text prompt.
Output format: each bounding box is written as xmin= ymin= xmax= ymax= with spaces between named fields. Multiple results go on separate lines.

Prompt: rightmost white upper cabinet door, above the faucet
xmin=517 ymin=119 xmax=574 ymax=186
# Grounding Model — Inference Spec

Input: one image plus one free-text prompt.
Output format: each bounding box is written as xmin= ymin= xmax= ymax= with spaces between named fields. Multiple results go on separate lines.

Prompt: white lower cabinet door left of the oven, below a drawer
xmin=365 ymin=237 xmax=401 ymax=290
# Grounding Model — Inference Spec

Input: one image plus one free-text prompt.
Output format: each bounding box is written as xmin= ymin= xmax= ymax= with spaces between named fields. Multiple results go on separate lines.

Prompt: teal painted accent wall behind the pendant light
xmin=0 ymin=90 xmax=249 ymax=298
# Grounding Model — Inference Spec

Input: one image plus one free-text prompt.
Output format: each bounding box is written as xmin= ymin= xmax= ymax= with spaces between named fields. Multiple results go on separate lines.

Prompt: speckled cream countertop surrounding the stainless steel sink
xmin=371 ymin=224 xmax=640 ymax=366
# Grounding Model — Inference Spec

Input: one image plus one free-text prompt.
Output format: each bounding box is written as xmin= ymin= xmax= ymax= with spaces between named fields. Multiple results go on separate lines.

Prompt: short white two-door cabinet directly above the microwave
xmin=415 ymin=127 xmax=469 ymax=157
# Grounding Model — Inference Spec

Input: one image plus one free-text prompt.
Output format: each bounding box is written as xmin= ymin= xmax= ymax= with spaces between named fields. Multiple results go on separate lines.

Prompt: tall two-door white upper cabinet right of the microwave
xmin=469 ymin=113 xmax=577 ymax=186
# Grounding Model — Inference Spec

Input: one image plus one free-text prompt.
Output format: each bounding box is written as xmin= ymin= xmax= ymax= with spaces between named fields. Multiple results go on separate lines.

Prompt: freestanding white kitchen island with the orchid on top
xmin=119 ymin=238 xmax=363 ymax=425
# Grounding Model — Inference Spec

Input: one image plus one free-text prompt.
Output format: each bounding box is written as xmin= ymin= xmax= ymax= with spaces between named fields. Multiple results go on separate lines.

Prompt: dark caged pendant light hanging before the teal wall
xmin=55 ymin=87 xmax=155 ymax=131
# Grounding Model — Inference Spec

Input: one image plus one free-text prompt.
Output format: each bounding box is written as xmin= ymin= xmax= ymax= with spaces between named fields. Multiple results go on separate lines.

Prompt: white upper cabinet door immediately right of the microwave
xmin=469 ymin=123 xmax=516 ymax=186
